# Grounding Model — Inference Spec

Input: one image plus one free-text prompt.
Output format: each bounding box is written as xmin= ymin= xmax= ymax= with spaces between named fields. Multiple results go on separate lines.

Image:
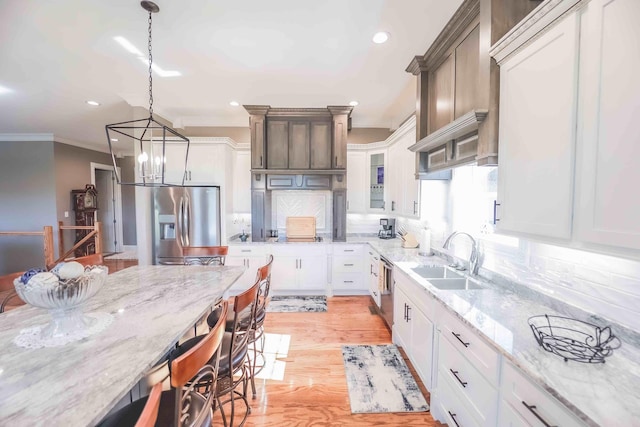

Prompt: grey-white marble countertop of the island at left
xmin=0 ymin=266 xmax=245 ymax=426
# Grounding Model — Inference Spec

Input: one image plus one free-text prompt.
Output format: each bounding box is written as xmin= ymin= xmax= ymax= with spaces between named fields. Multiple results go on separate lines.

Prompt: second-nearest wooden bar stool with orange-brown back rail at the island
xmin=98 ymin=301 xmax=229 ymax=427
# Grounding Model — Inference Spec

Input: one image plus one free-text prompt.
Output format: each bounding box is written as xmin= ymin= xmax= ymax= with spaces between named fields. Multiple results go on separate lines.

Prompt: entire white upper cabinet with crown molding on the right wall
xmin=491 ymin=0 xmax=640 ymax=254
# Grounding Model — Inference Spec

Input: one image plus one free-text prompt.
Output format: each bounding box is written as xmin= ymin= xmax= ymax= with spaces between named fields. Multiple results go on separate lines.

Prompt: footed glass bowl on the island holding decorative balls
xmin=13 ymin=265 xmax=108 ymax=339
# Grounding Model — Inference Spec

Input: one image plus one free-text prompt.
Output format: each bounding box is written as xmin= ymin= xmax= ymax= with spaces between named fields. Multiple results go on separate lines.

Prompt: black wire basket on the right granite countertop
xmin=529 ymin=314 xmax=621 ymax=363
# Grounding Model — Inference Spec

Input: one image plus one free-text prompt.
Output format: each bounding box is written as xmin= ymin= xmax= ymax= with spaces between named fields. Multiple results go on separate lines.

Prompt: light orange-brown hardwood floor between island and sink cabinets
xmin=214 ymin=297 xmax=443 ymax=427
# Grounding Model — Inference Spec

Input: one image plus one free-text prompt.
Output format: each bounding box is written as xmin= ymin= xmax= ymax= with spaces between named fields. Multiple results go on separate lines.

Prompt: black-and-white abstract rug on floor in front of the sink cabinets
xmin=342 ymin=345 xmax=429 ymax=414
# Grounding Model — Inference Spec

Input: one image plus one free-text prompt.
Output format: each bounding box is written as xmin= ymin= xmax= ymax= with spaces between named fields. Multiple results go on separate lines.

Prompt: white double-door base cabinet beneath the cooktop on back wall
xmin=270 ymin=244 xmax=328 ymax=295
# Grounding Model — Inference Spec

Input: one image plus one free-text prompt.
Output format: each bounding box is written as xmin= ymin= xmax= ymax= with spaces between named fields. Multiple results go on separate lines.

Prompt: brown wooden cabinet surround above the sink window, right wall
xmin=406 ymin=0 xmax=540 ymax=178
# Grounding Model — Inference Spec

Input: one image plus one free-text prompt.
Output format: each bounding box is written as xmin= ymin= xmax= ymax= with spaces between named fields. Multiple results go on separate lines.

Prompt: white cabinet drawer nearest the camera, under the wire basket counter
xmin=500 ymin=361 xmax=582 ymax=427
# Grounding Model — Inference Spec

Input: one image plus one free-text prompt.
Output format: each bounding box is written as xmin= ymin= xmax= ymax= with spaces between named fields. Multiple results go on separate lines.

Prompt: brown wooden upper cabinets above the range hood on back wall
xmin=245 ymin=105 xmax=353 ymax=174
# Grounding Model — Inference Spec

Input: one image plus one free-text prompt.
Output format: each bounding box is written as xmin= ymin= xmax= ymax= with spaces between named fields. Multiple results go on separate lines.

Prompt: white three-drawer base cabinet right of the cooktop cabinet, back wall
xmin=331 ymin=244 xmax=369 ymax=295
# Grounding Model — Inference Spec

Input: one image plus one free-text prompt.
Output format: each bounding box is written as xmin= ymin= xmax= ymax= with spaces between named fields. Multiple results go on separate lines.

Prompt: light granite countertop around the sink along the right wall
xmin=228 ymin=234 xmax=640 ymax=426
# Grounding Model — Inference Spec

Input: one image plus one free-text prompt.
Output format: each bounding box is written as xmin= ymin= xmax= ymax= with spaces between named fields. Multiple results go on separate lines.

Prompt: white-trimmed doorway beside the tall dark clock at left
xmin=91 ymin=163 xmax=122 ymax=254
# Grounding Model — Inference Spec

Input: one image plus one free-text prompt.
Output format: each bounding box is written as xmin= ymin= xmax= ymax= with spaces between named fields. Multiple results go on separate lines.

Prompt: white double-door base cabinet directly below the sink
xmin=393 ymin=269 xmax=434 ymax=390
